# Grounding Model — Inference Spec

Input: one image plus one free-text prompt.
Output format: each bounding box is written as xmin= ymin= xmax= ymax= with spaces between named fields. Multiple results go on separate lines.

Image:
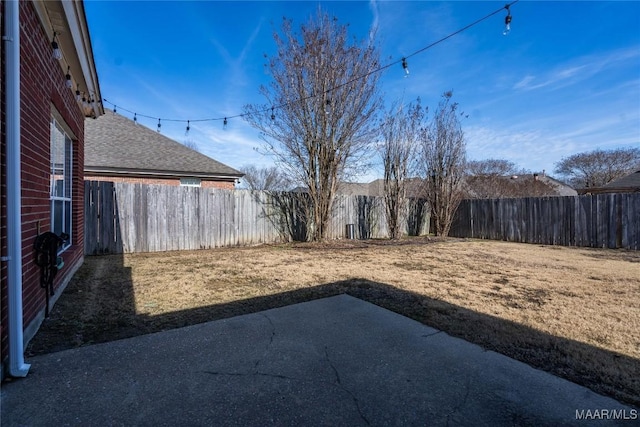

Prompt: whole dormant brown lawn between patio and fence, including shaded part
xmin=28 ymin=238 xmax=640 ymax=405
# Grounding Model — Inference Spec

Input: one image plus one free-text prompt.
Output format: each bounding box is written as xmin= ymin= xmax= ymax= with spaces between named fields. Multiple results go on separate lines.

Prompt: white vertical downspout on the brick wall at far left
xmin=3 ymin=0 xmax=30 ymax=377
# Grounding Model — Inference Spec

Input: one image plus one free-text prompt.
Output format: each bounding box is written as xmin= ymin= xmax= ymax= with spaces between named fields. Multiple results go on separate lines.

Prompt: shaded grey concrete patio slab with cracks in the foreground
xmin=1 ymin=295 xmax=638 ymax=426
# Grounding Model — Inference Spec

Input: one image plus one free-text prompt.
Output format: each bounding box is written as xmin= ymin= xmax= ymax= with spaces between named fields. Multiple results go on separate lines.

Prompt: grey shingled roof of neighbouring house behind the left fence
xmin=84 ymin=110 xmax=243 ymax=180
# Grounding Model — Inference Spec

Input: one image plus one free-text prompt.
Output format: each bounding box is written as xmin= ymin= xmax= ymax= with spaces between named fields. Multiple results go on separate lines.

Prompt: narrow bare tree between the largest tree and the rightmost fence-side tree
xmin=380 ymin=99 xmax=425 ymax=239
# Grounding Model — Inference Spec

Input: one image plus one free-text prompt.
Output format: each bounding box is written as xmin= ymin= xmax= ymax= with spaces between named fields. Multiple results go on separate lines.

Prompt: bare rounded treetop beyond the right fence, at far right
xmin=555 ymin=148 xmax=640 ymax=188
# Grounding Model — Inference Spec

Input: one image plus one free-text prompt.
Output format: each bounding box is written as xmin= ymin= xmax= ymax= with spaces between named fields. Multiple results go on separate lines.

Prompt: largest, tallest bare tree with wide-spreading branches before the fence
xmin=245 ymin=10 xmax=380 ymax=240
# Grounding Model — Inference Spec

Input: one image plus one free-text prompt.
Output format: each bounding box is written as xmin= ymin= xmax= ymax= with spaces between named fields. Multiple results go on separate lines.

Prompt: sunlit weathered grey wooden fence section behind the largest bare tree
xmin=85 ymin=181 xmax=429 ymax=255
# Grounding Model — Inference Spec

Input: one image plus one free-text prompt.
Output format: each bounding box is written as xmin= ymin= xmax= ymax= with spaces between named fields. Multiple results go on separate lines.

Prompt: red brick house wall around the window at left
xmin=1 ymin=2 xmax=84 ymax=361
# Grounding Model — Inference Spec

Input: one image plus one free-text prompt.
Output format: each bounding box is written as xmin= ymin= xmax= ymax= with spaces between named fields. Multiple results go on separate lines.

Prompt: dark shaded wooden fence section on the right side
xmin=449 ymin=193 xmax=640 ymax=250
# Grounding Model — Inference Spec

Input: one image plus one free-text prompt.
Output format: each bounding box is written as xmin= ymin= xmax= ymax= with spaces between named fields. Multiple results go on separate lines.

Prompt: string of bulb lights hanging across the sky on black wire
xmin=101 ymin=0 xmax=520 ymax=132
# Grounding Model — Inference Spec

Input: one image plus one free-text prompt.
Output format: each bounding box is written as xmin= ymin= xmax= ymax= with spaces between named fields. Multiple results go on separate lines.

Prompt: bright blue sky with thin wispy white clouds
xmin=85 ymin=0 xmax=640 ymax=181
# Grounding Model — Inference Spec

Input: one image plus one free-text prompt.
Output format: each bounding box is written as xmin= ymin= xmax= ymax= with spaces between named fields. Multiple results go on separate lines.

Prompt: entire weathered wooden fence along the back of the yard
xmin=85 ymin=181 xmax=640 ymax=255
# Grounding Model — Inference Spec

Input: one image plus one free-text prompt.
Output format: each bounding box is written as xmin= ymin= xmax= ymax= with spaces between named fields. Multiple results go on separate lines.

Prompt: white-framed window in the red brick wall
xmin=50 ymin=119 xmax=73 ymax=250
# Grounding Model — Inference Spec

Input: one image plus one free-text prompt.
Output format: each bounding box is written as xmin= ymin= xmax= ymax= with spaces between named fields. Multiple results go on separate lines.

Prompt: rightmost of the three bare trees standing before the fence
xmin=419 ymin=91 xmax=466 ymax=236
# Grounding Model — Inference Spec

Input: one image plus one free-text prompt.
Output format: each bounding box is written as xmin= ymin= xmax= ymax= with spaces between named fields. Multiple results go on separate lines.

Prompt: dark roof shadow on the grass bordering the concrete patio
xmin=27 ymin=255 xmax=640 ymax=406
